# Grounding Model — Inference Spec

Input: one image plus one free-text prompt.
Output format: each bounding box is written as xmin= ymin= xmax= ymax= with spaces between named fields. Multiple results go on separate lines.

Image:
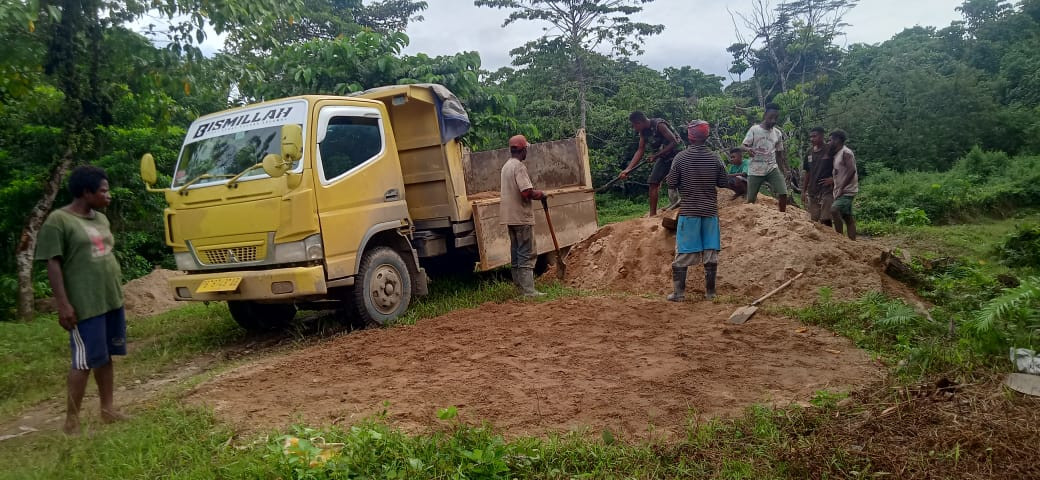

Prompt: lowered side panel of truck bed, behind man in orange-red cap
xmin=473 ymin=187 xmax=598 ymax=271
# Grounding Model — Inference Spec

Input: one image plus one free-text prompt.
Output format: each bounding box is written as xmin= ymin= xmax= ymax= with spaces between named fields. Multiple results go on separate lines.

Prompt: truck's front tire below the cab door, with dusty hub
xmin=354 ymin=246 xmax=412 ymax=325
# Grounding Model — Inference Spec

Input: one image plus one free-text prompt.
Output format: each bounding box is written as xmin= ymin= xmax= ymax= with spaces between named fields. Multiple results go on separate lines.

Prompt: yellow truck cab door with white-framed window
xmin=315 ymin=104 xmax=408 ymax=279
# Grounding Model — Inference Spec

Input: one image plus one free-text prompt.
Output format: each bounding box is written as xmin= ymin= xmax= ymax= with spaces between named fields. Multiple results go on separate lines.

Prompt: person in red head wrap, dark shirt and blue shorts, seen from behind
xmin=667 ymin=121 xmax=729 ymax=301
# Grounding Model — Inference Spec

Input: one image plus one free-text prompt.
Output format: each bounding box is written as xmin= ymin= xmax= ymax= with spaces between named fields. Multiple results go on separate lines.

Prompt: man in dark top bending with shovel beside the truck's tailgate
xmin=618 ymin=111 xmax=682 ymax=216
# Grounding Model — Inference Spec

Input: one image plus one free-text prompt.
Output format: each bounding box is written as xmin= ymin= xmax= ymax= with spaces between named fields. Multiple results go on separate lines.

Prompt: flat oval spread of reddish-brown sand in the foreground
xmin=188 ymin=297 xmax=883 ymax=438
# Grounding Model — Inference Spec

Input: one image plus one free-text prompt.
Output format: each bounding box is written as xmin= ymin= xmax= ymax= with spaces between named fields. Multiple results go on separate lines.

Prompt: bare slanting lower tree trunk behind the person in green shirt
xmin=15 ymin=148 xmax=73 ymax=321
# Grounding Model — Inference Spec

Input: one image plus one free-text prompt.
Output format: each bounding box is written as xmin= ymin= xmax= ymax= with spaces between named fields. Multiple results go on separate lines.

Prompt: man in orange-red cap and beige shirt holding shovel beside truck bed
xmin=498 ymin=135 xmax=546 ymax=297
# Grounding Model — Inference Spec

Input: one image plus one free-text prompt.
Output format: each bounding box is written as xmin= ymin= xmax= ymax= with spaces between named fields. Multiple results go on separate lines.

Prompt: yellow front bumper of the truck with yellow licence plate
xmin=170 ymin=265 xmax=329 ymax=301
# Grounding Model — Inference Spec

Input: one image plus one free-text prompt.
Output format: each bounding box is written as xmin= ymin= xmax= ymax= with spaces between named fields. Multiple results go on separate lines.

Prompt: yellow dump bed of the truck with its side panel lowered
xmin=359 ymin=85 xmax=597 ymax=270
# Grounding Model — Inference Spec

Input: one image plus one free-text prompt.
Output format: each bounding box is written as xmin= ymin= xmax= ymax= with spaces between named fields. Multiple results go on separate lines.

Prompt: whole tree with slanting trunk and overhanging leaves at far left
xmin=11 ymin=0 xmax=300 ymax=319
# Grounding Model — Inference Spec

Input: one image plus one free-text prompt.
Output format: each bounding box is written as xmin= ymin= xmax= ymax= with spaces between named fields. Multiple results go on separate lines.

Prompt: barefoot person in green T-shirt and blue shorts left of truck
xmin=35 ymin=166 xmax=127 ymax=435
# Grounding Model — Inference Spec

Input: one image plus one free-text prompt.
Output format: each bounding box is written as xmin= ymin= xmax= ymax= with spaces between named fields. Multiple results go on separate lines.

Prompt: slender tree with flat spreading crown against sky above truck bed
xmin=473 ymin=0 xmax=665 ymax=129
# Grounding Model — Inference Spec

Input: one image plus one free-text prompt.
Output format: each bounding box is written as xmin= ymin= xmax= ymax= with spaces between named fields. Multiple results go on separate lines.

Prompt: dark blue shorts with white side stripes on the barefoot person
xmin=69 ymin=306 xmax=127 ymax=370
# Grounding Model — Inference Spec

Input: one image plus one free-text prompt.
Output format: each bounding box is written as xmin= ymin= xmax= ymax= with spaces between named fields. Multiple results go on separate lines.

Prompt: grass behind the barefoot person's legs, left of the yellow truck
xmin=0 ymin=303 xmax=245 ymax=419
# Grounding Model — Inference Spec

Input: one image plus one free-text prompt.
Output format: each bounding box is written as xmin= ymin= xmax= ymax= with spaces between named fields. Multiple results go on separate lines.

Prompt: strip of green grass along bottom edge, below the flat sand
xmin=0 ymin=401 xmax=827 ymax=479
